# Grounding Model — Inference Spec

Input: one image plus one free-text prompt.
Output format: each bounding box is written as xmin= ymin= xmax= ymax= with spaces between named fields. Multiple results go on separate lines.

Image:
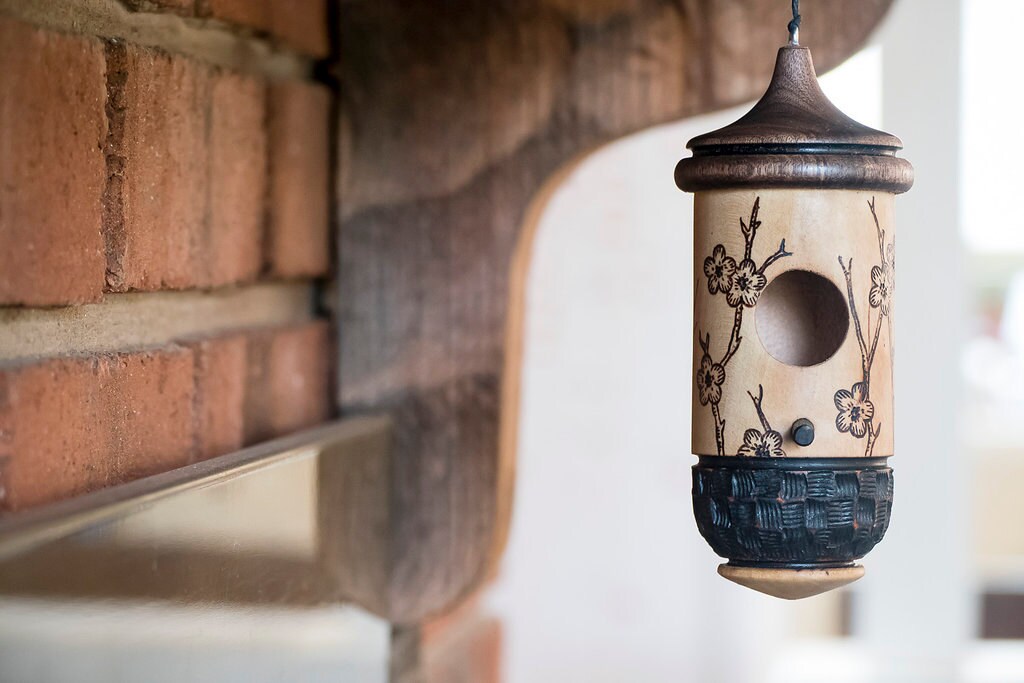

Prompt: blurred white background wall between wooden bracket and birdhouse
xmin=485 ymin=108 xmax=798 ymax=683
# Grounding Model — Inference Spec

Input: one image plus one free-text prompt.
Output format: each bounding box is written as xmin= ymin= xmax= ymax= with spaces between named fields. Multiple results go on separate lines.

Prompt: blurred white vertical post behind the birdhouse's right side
xmin=856 ymin=0 xmax=970 ymax=683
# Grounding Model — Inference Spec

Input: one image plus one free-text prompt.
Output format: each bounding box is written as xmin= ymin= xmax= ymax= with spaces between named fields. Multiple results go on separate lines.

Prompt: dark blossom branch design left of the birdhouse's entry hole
xmin=694 ymin=197 xmax=793 ymax=456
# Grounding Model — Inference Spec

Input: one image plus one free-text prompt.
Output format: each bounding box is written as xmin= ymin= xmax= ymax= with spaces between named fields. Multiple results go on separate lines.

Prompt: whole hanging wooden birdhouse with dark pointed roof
xmin=676 ymin=24 xmax=913 ymax=599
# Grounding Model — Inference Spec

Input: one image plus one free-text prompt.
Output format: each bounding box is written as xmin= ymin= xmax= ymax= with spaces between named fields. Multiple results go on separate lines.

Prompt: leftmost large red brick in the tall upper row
xmin=0 ymin=17 xmax=106 ymax=306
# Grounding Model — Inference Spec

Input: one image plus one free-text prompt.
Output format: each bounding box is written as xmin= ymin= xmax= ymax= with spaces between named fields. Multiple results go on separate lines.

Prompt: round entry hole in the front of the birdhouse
xmin=754 ymin=270 xmax=850 ymax=367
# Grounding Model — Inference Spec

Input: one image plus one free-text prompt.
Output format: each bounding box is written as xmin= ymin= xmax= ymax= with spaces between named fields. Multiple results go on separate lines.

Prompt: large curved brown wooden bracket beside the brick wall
xmin=337 ymin=0 xmax=890 ymax=624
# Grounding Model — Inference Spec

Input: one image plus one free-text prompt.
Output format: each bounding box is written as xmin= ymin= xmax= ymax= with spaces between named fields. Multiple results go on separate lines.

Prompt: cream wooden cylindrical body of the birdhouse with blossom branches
xmin=692 ymin=189 xmax=895 ymax=458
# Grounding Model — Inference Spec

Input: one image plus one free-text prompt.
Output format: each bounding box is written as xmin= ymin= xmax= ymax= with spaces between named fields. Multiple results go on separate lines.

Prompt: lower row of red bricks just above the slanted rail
xmin=0 ymin=321 xmax=332 ymax=511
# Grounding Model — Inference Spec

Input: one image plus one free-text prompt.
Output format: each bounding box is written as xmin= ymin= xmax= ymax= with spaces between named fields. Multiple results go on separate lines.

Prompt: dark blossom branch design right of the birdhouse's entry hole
xmin=834 ymin=197 xmax=896 ymax=458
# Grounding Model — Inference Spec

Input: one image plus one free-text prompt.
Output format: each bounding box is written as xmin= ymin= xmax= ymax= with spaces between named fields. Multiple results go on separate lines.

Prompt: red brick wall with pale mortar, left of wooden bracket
xmin=0 ymin=0 xmax=334 ymax=511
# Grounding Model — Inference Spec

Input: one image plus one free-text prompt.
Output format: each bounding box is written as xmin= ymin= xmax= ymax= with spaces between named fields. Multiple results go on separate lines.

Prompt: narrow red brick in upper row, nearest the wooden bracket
xmin=267 ymin=83 xmax=331 ymax=278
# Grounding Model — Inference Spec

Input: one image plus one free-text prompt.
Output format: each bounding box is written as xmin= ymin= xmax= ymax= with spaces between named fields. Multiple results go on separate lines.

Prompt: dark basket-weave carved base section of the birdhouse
xmin=693 ymin=456 xmax=893 ymax=568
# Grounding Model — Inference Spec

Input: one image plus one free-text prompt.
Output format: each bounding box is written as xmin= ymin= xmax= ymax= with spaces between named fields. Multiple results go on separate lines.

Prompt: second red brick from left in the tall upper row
xmin=104 ymin=43 xmax=210 ymax=291
